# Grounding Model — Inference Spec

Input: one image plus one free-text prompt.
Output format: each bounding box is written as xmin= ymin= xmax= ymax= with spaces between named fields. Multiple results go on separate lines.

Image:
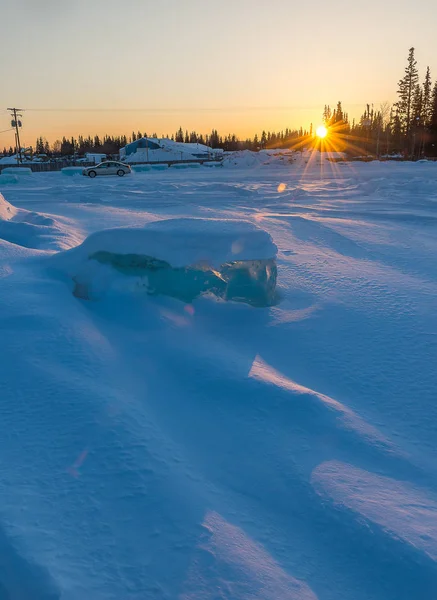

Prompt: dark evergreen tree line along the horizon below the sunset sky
xmin=3 ymin=48 xmax=437 ymax=158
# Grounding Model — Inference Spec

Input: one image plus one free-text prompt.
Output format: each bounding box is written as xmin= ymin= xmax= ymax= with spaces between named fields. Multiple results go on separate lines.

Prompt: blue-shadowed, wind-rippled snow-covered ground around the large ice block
xmin=0 ymin=159 xmax=437 ymax=600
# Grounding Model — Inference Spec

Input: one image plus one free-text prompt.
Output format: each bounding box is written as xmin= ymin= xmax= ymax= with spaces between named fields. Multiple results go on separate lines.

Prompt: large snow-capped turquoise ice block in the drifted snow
xmin=49 ymin=219 xmax=277 ymax=306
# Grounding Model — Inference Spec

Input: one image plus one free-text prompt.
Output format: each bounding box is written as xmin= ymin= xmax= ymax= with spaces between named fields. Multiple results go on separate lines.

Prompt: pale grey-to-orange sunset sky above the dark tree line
xmin=0 ymin=0 xmax=437 ymax=148
